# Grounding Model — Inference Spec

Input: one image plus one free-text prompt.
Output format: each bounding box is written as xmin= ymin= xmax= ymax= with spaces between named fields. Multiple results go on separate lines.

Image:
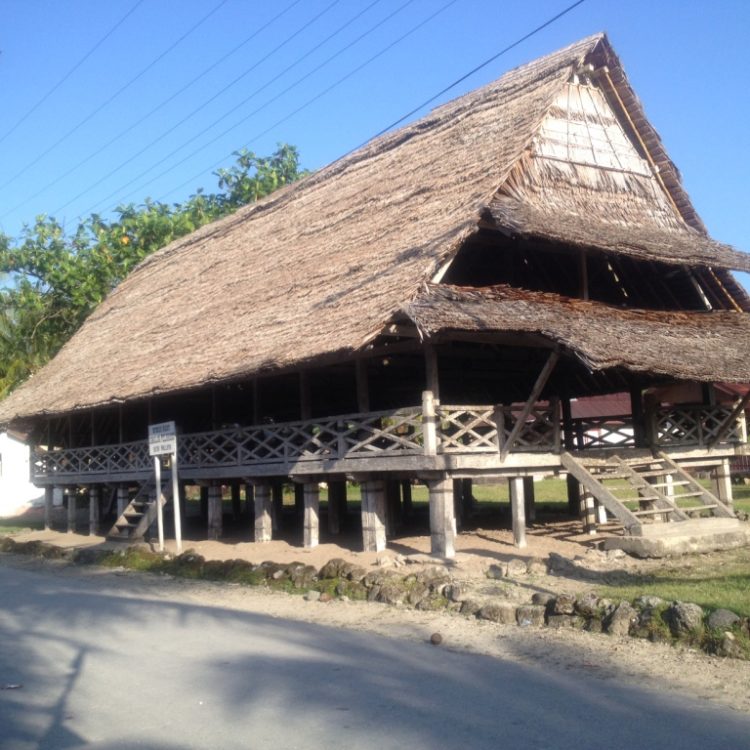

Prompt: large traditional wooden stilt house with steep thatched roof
xmin=0 ymin=35 xmax=750 ymax=556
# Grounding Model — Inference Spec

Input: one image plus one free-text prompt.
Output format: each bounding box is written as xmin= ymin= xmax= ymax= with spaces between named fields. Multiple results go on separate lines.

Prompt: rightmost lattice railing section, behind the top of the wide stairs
xmin=652 ymin=406 xmax=742 ymax=447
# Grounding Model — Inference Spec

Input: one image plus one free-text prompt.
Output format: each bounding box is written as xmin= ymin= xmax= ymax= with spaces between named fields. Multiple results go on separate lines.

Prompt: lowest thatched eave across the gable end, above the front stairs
xmin=404 ymin=284 xmax=750 ymax=382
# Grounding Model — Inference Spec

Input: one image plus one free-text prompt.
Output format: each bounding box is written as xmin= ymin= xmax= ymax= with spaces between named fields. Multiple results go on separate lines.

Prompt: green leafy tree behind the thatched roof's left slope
xmin=0 ymin=144 xmax=304 ymax=398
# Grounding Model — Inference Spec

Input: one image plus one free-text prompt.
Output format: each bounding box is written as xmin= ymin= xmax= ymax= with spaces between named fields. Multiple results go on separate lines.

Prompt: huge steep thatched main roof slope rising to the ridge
xmin=0 ymin=35 xmax=748 ymax=423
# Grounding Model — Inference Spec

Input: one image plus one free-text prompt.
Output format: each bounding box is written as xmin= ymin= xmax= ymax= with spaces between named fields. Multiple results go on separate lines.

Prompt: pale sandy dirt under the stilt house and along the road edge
xmin=6 ymin=508 xmax=750 ymax=711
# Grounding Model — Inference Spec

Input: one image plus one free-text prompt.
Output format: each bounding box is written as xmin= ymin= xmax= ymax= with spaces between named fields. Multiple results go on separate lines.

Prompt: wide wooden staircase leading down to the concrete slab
xmin=562 ymin=453 xmax=735 ymax=537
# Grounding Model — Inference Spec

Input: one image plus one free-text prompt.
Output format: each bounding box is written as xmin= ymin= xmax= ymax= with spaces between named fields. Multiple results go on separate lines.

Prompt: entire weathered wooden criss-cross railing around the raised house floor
xmin=32 ymin=401 xmax=741 ymax=480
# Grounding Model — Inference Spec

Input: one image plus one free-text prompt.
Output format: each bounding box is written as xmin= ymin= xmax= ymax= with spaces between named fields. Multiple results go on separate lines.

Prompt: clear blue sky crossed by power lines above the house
xmin=0 ymin=0 xmax=750 ymax=266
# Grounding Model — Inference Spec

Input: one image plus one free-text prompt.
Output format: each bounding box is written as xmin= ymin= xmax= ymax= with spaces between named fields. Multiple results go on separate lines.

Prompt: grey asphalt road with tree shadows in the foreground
xmin=0 ymin=562 xmax=750 ymax=750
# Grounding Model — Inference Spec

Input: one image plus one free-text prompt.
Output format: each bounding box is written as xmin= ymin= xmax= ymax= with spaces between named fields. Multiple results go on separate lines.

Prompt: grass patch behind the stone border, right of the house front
xmin=597 ymin=548 xmax=750 ymax=617
